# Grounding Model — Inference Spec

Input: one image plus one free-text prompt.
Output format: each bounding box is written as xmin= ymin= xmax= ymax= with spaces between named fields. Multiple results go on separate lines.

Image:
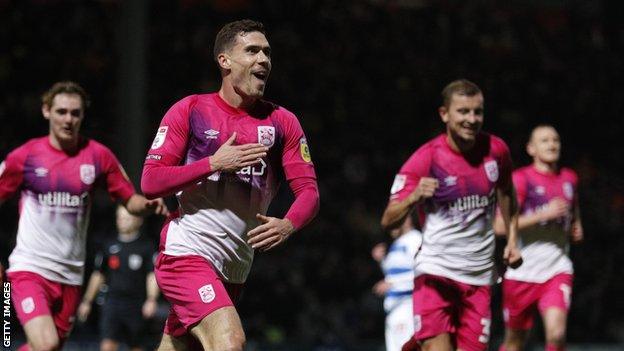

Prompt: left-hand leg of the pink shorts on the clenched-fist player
xmin=413 ymin=274 xmax=455 ymax=340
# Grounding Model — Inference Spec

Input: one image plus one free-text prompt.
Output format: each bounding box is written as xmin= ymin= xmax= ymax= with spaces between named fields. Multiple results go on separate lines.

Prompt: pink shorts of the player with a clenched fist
xmin=413 ymin=274 xmax=491 ymax=351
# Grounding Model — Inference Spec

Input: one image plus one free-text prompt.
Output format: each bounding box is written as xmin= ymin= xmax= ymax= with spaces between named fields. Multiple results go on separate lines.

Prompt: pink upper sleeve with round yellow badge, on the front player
xmin=281 ymin=112 xmax=316 ymax=181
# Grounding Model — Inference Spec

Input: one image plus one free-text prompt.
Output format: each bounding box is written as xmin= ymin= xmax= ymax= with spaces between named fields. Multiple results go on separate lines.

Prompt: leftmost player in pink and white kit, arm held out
xmin=0 ymin=82 xmax=166 ymax=350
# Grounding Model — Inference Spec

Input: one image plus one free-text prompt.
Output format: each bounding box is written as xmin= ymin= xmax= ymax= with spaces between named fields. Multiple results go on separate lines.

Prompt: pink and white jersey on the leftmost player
xmin=0 ymin=136 xmax=134 ymax=285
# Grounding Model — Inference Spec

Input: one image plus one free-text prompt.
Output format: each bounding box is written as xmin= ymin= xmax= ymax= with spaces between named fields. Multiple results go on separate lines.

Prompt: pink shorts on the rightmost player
xmin=503 ymin=273 xmax=573 ymax=330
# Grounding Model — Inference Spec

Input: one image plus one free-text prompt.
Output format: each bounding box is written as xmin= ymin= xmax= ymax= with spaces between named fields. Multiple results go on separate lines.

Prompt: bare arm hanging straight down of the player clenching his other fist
xmin=497 ymin=182 xmax=522 ymax=268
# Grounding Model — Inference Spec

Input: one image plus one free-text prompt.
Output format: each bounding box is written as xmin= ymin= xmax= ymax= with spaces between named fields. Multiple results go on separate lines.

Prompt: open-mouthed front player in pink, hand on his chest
xmin=141 ymin=20 xmax=319 ymax=350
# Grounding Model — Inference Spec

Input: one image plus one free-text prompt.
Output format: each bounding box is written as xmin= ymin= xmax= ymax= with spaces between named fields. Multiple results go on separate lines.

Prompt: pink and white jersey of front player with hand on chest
xmin=144 ymin=93 xmax=316 ymax=283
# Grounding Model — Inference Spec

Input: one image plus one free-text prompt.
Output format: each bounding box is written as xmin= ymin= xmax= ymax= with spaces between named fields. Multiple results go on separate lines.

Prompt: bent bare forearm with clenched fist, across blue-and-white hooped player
xmin=381 ymin=177 xmax=439 ymax=230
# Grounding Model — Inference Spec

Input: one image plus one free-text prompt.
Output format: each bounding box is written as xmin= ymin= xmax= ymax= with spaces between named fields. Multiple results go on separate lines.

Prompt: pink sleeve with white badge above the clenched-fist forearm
xmin=390 ymin=144 xmax=432 ymax=201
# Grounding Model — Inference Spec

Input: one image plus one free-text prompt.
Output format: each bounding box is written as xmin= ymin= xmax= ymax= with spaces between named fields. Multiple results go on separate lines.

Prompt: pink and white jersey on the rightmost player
xmin=505 ymin=165 xmax=578 ymax=283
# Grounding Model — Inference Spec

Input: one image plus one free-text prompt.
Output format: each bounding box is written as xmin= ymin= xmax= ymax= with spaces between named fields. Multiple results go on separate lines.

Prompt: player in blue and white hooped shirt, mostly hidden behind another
xmin=371 ymin=215 xmax=422 ymax=351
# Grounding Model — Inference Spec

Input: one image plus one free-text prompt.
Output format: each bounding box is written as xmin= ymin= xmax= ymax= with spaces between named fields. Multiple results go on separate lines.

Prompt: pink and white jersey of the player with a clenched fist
xmin=390 ymin=133 xmax=511 ymax=285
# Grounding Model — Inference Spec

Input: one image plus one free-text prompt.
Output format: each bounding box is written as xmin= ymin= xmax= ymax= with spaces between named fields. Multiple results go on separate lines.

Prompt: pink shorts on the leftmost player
xmin=7 ymin=271 xmax=80 ymax=342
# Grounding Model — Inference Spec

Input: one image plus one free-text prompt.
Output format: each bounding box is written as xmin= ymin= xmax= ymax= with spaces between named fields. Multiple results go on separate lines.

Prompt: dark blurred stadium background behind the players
xmin=0 ymin=0 xmax=624 ymax=349
